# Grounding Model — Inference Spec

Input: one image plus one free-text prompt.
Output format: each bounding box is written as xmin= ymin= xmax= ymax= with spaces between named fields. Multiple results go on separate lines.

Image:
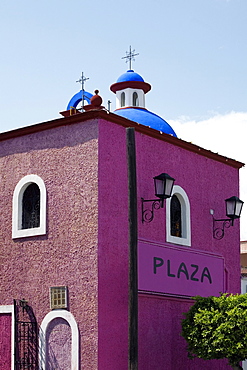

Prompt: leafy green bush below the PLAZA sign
xmin=182 ymin=294 xmax=247 ymax=369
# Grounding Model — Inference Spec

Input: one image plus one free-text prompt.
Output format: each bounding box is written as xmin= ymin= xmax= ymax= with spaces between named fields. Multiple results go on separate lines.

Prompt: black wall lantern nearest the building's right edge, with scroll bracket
xmin=213 ymin=196 xmax=244 ymax=240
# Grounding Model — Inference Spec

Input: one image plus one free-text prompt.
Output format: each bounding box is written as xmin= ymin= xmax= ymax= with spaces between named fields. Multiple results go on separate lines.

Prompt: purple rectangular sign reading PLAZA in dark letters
xmin=138 ymin=241 xmax=225 ymax=297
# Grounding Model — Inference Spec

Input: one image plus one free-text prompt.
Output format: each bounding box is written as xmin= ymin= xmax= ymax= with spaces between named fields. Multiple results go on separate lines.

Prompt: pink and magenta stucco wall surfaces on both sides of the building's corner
xmin=0 ymin=116 xmax=240 ymax=370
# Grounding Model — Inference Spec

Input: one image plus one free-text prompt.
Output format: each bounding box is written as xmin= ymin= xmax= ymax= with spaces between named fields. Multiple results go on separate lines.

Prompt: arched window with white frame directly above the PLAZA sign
xmin=166 ymin=185 xmax=191 ymax=246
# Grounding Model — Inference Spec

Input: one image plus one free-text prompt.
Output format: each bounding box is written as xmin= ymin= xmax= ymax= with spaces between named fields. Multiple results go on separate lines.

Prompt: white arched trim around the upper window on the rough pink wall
xmin=12 ymin=175 xmax=46 ymax=239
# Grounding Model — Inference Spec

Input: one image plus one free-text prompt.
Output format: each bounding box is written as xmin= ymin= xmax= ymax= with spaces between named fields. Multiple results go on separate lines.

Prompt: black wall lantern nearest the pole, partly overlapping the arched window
xmin=141 ymin=173 xmax=175 ymax=222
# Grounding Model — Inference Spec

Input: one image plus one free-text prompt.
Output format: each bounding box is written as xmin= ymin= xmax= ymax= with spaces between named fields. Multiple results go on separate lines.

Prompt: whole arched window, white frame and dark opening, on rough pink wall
xmin=12 ymin=175 xmax=46 ymax=238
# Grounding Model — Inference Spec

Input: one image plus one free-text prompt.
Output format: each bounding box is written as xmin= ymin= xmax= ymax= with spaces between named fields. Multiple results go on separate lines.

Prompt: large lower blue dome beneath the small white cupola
xmin=114 ymin=108 xmax=177 ymax=137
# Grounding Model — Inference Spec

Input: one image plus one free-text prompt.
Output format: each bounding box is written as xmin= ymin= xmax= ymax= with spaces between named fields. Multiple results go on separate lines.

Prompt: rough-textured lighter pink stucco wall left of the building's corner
xmin=0 ymin=121 xmax=98 ymax=370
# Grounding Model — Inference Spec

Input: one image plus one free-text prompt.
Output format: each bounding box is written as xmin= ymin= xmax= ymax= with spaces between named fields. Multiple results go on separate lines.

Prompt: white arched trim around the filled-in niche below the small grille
xmin=39 ymin=310 xmax=79 ymax=370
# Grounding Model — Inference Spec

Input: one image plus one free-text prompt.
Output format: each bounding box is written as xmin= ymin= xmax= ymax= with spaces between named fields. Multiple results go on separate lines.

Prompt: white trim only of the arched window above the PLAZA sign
xmin=166 ymin=185 xmax=191 ymax=247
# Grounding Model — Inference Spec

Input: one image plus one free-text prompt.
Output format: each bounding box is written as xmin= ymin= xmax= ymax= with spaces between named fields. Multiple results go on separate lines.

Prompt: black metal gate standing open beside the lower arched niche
xmin=14 ymin=299 xmax=38 ymax=370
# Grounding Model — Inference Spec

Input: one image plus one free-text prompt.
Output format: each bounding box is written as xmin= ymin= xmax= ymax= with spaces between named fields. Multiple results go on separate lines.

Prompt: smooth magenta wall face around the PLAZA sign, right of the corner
xmin=99 ymin=117 xmax=240 ymax=370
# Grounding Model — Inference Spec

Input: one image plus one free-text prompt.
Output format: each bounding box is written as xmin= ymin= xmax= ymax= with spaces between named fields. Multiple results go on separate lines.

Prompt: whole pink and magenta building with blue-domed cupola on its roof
xmin=0 ymin=71 xmax=243 ymax=370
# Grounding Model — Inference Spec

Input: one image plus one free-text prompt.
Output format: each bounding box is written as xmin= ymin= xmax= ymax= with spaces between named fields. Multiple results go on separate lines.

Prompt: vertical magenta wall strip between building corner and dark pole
xmin=98 ymin=121 xmax=128 ymax=370
